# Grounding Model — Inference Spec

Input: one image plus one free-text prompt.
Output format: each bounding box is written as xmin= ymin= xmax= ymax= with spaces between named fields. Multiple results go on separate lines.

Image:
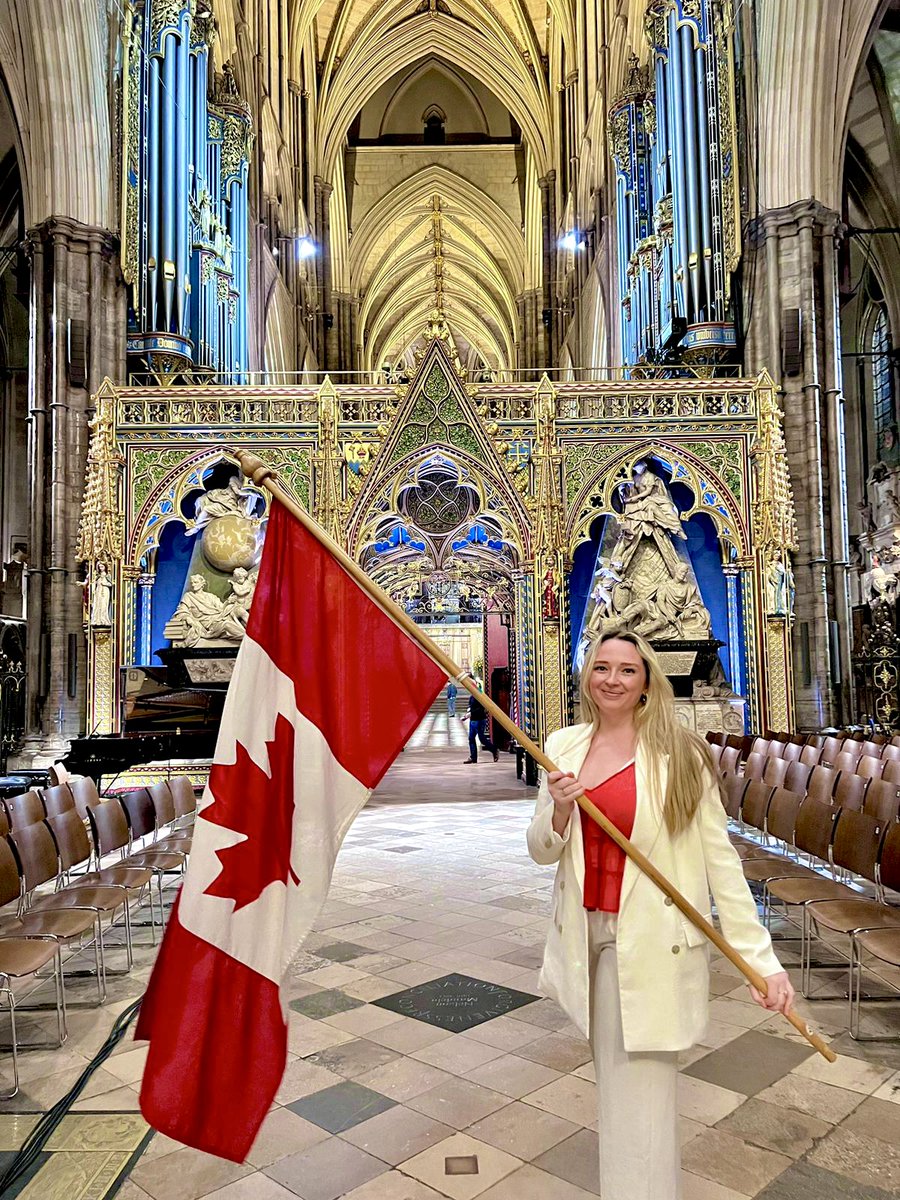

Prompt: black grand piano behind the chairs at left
xmin=62 ymin=664 xmax=226 ymax=786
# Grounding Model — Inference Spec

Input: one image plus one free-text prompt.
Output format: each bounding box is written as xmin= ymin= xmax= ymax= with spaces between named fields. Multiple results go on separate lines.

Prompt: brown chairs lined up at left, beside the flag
xmin=0 ymin=780 xmax=196 ymax=1098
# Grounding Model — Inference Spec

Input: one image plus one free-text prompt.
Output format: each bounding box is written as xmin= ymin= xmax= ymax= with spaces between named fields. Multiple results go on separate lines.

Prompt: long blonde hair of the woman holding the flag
xmin=581 ymin=628 xmax=715 ymax=835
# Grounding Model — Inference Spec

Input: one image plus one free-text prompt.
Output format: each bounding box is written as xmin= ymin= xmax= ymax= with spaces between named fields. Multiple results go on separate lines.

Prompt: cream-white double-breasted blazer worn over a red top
xmin=527 ymin=725 xmax=782 ymax=1052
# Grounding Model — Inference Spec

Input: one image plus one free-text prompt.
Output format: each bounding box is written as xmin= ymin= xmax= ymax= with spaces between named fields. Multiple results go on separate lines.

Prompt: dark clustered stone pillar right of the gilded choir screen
xmin=744 ymin=200 xmax=853 ymax=728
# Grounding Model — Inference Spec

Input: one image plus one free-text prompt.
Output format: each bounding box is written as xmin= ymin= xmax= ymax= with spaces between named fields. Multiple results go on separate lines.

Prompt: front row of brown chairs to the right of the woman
xmin=724 ymin=775 xmax=900 ymax=1038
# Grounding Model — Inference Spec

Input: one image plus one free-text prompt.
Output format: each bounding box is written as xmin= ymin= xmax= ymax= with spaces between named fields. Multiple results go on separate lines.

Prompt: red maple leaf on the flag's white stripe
xmin=203 ymin=713 xmax=300 ymax=912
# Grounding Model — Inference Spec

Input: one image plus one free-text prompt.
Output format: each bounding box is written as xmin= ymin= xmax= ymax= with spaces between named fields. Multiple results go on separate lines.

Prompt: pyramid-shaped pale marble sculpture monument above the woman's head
xmin=581 ymin=461 xmax=731 ymax=697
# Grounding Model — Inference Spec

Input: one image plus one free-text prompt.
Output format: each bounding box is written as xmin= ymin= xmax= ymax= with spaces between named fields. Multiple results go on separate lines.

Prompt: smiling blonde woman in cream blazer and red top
xmin=528 ymin=630 xmax=793 ymax=1200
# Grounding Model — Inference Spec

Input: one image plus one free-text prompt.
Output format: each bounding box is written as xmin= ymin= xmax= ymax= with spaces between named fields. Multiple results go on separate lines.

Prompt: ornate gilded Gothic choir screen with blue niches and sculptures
xmin=78 ymin=336 xmax=794 ymax=737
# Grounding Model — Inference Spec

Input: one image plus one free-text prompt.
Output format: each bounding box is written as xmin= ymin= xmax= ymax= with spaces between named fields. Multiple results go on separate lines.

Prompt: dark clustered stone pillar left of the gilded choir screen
xmin=25 ymin=217 xmax=125 ymax=761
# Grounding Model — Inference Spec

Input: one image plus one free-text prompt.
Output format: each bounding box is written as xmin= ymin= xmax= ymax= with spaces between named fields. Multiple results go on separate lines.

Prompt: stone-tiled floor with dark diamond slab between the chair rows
xmin=0 ymin=716 xmax=900 ymax=1200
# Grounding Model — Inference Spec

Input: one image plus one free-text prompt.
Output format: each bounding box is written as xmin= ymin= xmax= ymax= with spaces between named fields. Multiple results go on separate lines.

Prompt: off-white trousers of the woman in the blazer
xmin=588 ymin=912 xmax=682 ymax=1200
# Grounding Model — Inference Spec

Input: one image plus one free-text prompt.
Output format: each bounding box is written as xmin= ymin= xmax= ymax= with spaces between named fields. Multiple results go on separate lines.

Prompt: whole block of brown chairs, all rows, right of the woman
xmin=707 ymin=733 xmax=900 ymax=1038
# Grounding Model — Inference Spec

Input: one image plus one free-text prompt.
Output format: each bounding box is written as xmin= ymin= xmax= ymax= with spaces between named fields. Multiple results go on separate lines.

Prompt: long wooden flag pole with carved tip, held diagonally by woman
xmin=230 ymin=450 xmax=838 ymax=1062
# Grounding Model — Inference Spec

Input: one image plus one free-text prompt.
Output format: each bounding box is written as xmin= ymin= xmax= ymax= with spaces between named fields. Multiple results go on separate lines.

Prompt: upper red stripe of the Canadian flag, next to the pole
xmin=247 ymin=503 xmax=445 ymax=787
